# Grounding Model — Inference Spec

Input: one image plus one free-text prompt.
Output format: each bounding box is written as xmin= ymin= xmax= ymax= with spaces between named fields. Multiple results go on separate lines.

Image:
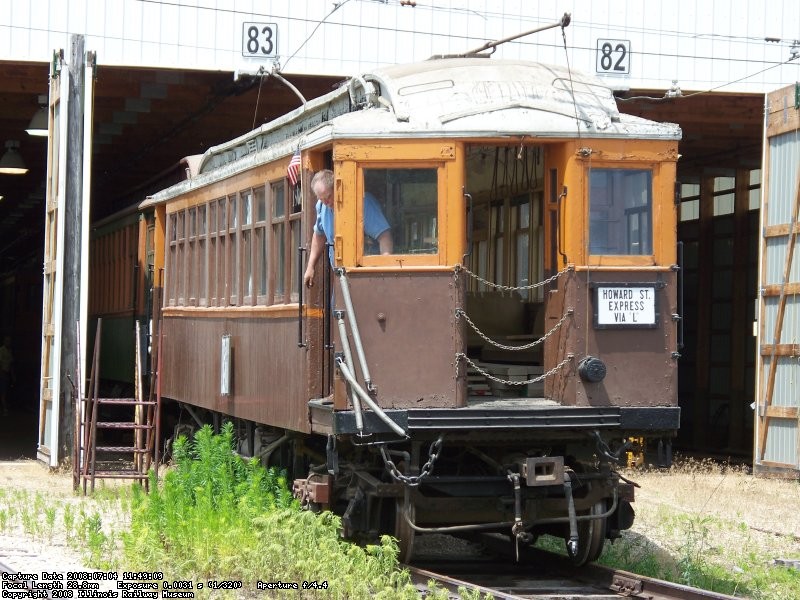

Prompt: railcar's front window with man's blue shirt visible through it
xmin=363 ymin=168 xmax=439 ymax=255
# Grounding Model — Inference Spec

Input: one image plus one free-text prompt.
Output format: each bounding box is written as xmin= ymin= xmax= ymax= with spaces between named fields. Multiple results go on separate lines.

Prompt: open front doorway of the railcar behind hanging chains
xmin=465 ymin=145 xmax=545 ymax=396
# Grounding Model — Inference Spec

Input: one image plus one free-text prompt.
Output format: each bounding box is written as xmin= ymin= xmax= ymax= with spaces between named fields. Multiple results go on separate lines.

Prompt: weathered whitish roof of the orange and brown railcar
xmin=142 ymin=58 xmax=681 ymax=207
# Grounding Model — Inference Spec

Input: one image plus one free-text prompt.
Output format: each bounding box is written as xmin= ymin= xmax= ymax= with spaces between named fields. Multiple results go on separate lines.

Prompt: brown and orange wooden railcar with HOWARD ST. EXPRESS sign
xmin=142 ymin=58 xmax=680 ymax=564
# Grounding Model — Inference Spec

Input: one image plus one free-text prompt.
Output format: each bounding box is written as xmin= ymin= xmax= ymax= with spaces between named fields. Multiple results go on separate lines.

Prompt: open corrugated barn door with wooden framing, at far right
xmin=754 ymin=86 xmax=800 ymax=477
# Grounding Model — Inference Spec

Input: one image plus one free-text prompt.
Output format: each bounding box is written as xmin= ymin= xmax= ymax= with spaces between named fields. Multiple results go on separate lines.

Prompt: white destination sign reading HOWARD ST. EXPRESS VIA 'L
xmin=595 ymin=284 xmax=656 ymax=328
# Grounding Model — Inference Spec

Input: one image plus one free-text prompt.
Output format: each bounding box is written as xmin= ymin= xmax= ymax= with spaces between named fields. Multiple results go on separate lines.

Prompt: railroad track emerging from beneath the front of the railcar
xmin=406 ymin=542 xmax=734 ymax=600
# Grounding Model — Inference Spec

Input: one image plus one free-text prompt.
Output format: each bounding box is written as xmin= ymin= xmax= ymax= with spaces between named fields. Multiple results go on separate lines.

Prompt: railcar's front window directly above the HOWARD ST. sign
xmin=589 ymin=169 xmax=653 ymax=255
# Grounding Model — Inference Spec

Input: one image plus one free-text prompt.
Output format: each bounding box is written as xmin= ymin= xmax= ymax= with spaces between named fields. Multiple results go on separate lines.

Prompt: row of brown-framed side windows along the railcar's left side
xmin=162 ymin=171 xmax=304 ymax=308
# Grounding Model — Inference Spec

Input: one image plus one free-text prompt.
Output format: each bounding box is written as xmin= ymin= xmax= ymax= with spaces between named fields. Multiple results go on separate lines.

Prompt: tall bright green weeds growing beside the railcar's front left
xmin=122 ymin=423 xmax=444 ymax=599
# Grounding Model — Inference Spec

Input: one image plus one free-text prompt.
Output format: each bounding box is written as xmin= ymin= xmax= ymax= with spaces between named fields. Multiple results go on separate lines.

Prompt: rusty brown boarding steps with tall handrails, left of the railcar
xmin=73 ymin=319 xmax=160 ymax=495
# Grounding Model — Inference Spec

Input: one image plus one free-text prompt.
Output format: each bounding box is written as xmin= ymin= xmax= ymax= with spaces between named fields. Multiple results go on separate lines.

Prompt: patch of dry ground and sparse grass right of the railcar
xmin=599 ymin=459 xmax=800 ymax=600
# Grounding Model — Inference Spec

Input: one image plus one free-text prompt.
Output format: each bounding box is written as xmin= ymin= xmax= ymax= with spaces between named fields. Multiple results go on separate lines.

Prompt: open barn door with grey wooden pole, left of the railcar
xmin=37 ymin=36 xmax=95 ymax=467
